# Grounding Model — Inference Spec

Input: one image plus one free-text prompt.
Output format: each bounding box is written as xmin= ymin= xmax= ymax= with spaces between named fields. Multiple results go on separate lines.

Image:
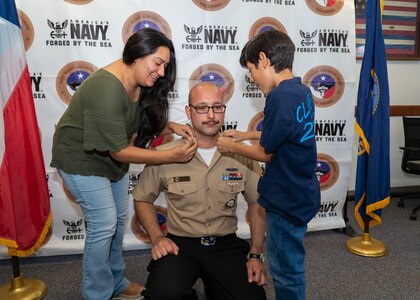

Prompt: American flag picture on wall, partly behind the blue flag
xmin=355 ymin=0 xmax=419 ymax=58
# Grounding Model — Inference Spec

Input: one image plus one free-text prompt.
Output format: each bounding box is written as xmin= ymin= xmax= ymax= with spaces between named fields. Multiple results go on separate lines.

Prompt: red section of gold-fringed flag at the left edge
xmin=0 ymin=66 xmax=51 ymax=256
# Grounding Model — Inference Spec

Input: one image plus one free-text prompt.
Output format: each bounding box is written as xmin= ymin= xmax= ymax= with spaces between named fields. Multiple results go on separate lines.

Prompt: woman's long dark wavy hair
xmin=122 ymin=28 xmax=176 ymax=148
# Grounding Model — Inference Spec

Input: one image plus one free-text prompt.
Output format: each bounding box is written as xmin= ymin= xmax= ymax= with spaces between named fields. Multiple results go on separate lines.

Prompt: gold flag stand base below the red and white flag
xmin=0 ymin=276 xmax=47 ymax=300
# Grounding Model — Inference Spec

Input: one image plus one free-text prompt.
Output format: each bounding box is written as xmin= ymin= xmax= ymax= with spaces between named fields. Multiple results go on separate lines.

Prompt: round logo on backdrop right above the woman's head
xmin=122 ymin=11 xmax=172 ymax=44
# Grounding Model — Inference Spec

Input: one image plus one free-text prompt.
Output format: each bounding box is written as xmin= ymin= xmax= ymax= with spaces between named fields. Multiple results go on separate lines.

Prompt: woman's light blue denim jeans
xmin=58 ymin=169 xmax=129 ymax=300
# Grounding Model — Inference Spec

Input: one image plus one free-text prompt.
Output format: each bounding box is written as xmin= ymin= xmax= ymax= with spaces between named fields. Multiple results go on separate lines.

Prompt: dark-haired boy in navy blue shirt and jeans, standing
xmin=218 ymin=29 xmax=320 ymax=300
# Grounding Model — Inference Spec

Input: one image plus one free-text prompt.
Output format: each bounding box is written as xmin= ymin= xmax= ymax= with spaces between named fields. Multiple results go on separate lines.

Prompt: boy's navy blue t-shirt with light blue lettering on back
xmin=258 ymin=77 xmax=321 ymax=226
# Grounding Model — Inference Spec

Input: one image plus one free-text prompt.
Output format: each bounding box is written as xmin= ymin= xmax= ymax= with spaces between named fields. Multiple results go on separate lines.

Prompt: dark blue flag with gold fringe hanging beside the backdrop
xmin=355 ymin=0 xmax=390 ymax=229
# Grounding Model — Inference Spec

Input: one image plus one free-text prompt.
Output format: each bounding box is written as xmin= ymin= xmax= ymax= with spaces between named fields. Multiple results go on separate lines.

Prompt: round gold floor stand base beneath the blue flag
xmin=346 ymin=233 xmax=388 ymax=257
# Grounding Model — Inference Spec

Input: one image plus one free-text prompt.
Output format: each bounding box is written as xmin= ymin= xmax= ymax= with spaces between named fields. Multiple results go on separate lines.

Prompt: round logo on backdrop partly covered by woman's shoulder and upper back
xmin=55 ymin=61 xmax=98 ymax=104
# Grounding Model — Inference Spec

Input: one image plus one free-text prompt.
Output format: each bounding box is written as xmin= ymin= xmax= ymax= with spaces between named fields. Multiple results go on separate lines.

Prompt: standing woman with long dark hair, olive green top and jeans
xmin=51 ymin=29 xmax=197 ymax=300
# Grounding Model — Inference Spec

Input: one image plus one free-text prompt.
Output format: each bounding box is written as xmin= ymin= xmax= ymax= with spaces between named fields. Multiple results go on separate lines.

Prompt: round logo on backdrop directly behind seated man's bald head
xmin=189 ymin=64 xmax=235 ymax=104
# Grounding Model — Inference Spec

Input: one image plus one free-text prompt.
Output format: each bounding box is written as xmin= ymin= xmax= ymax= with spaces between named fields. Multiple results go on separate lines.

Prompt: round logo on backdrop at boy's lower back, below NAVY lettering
xmin=315 ymin=153 xmax=340 ymax=191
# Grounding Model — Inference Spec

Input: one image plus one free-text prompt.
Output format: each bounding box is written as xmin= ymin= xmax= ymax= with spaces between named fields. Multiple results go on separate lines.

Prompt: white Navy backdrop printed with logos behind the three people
xmin=0 ymin=0 xmax=355 ymax=258
